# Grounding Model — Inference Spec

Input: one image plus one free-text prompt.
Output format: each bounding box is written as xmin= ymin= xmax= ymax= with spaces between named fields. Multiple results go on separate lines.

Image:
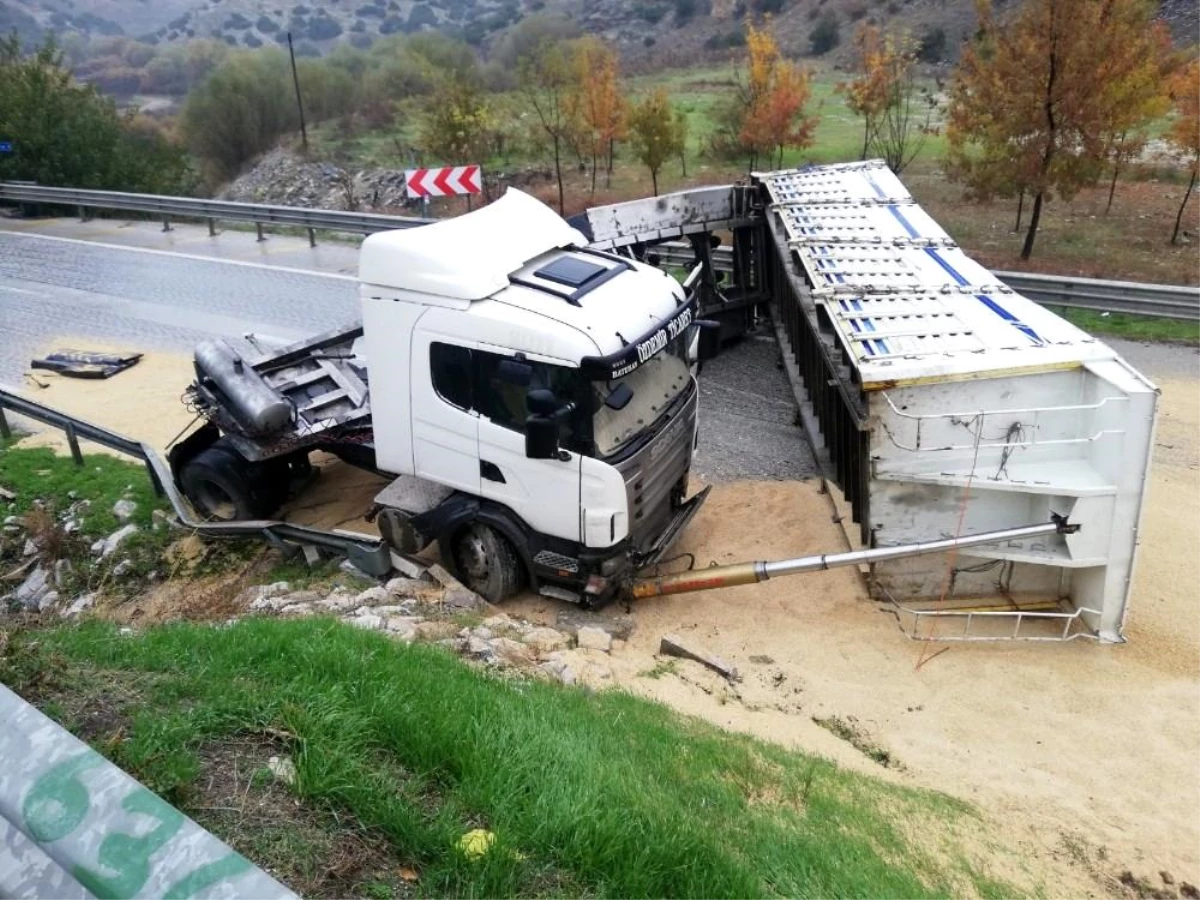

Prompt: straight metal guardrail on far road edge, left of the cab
xmin=0 ymin=181 xmax=434 ymax=247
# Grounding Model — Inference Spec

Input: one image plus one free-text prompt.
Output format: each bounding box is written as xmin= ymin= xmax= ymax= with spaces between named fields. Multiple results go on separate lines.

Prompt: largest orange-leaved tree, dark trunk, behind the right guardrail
xmin=947 ymin=0 xmax=1158 ymax=259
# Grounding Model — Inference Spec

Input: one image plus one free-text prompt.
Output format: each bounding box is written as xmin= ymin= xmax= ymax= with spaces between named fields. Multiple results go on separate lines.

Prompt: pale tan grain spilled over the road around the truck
xmin=16 ymin=343 xmax=1200 ymax=896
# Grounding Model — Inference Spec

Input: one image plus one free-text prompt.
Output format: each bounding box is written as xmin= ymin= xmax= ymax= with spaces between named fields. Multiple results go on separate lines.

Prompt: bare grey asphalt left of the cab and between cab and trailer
xmin=0 ymin=232 xmax=816 ymax=481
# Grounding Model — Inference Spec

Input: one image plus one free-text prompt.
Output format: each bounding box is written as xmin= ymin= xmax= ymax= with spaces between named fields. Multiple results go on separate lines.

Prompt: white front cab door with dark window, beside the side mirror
xmin=475 ymin=350 xmax=581 ymax=541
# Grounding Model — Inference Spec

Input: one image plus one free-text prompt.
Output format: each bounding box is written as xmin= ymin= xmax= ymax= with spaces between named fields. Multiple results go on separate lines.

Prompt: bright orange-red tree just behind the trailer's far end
xmin=739 ymin=25 xmax=816 ymax=168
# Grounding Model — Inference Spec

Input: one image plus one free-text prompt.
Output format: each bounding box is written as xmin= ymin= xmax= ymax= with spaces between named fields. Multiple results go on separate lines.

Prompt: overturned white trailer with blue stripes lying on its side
xmin=588 ymin=161 xmax=1158 ymax=641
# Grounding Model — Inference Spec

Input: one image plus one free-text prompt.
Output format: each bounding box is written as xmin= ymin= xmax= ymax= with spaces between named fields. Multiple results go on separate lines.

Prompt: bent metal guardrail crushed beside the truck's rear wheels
xmin=0 ymin=390 xmax=392 ymax=577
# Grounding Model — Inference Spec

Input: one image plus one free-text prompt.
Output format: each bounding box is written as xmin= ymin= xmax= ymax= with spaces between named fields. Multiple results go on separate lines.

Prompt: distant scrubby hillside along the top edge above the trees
xmin=7 ymin=0 xmax=1200 ymax=58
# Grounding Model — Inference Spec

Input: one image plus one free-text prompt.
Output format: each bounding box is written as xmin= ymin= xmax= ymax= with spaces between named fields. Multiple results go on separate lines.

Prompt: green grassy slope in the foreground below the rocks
xmin=0 ymin=619 xmax=1013 ymax=900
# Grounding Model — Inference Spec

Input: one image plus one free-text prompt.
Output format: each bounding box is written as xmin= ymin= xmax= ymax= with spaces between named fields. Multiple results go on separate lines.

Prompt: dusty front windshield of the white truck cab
xmin=593 ymin=328 xmax=692 ymax=456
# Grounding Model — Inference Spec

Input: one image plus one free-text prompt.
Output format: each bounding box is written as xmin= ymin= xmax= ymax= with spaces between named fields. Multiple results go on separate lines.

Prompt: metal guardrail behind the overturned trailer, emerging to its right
xmin=649 ymin=242 xmax=1200 ymax=322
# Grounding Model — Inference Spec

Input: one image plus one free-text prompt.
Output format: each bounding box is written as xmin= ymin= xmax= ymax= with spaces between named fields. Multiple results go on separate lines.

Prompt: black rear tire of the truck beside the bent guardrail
xmin=179 ymin=439 xmax=286 ymax=522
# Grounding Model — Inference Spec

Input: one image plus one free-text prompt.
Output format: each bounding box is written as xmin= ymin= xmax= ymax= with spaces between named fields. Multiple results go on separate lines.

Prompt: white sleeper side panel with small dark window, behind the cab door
xmin=410 ymin=334 xmax=479 ymax=496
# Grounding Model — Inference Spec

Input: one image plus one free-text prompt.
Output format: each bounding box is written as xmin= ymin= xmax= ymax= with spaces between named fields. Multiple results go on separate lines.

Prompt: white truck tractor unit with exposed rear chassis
xmin=173 ymin=191 xmax=704 ymax=601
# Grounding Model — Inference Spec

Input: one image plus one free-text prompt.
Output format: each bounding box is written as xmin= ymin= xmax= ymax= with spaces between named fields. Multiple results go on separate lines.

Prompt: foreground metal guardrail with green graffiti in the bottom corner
xmin=0 ymin=686 xmax=299 ymax=900
